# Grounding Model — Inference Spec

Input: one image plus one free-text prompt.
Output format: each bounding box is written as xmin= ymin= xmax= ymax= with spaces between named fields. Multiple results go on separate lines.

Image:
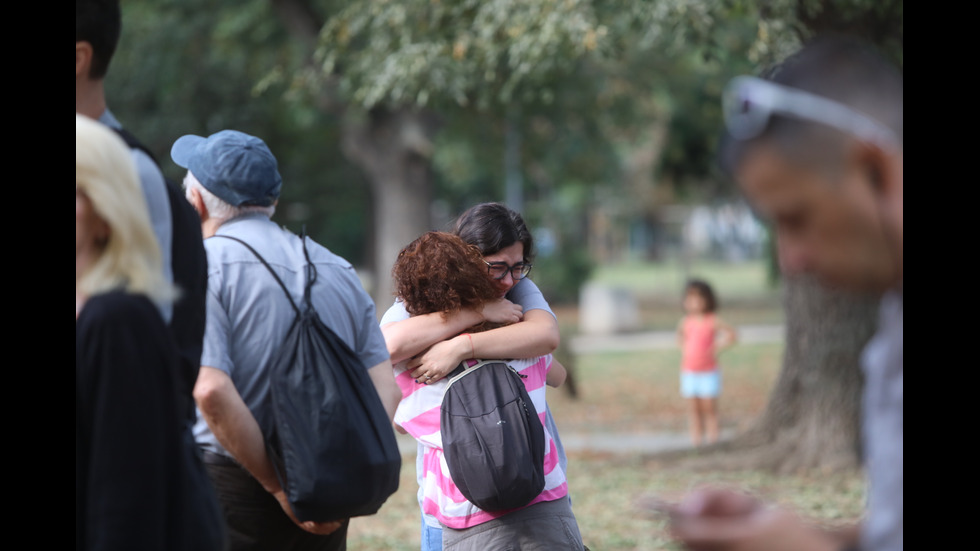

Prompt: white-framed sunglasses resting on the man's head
xmin=722 ymin=76 xmax=899 ymax=148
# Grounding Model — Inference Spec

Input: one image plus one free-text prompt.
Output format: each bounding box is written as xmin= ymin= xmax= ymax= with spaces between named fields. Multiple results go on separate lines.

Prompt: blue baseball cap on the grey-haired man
xmin=170 ymin=130 xmax=282 ymax=207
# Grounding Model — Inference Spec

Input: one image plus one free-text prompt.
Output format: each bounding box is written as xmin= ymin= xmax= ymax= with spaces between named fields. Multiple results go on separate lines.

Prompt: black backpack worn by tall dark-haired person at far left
xmin=110 ymin=127 xmax=208 ymax=420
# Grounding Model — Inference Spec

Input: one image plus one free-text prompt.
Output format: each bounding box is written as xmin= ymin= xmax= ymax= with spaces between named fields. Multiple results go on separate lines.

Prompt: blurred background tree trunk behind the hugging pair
xmin=343 ymin=108 xmax=436 ymax=308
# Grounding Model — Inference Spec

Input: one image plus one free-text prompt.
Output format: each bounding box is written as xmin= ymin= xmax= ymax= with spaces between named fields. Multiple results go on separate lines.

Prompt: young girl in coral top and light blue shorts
xmin=677 ymin=279 xmax=736 ymax=446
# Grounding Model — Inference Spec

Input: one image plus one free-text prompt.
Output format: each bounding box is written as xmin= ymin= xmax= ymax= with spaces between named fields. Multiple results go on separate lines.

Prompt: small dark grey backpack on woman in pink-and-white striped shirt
xmin=440 ymin=360 xmax=545 ymax=511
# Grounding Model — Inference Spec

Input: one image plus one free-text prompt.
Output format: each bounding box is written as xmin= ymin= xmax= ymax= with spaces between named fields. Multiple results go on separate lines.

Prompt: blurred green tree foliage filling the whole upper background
xmin=107 ymin=0 xmax=903 ymax=274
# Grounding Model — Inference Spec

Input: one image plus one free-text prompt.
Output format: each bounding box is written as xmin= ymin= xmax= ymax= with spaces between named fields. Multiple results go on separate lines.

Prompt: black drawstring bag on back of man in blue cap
xmin=216 ymin=235 xmax=401 ymax=522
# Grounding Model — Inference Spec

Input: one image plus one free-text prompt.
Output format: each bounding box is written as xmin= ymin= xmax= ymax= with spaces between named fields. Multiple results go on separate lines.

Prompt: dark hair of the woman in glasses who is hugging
xmin=453 ymin=203 xmax=534 ymax=262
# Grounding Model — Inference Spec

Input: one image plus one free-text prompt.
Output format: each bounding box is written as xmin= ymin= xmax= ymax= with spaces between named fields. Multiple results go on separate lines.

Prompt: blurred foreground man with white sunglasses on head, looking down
xmin=670 ymin=34 xmax=904 ymax=551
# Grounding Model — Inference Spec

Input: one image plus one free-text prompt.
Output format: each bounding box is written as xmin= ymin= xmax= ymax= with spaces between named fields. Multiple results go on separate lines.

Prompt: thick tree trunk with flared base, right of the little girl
xmin=672 ymin=277 xmax=877 ymax=473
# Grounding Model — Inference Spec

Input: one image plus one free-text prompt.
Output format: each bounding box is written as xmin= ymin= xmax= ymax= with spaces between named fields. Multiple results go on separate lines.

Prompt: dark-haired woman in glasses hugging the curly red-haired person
xmin=381 ymin=203 xmax=566 ymax=551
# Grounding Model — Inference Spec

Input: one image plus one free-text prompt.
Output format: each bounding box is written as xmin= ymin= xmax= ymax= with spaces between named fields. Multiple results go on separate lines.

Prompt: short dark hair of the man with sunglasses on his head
xmin=719 ymin=35 xmax=904 ymax=173
